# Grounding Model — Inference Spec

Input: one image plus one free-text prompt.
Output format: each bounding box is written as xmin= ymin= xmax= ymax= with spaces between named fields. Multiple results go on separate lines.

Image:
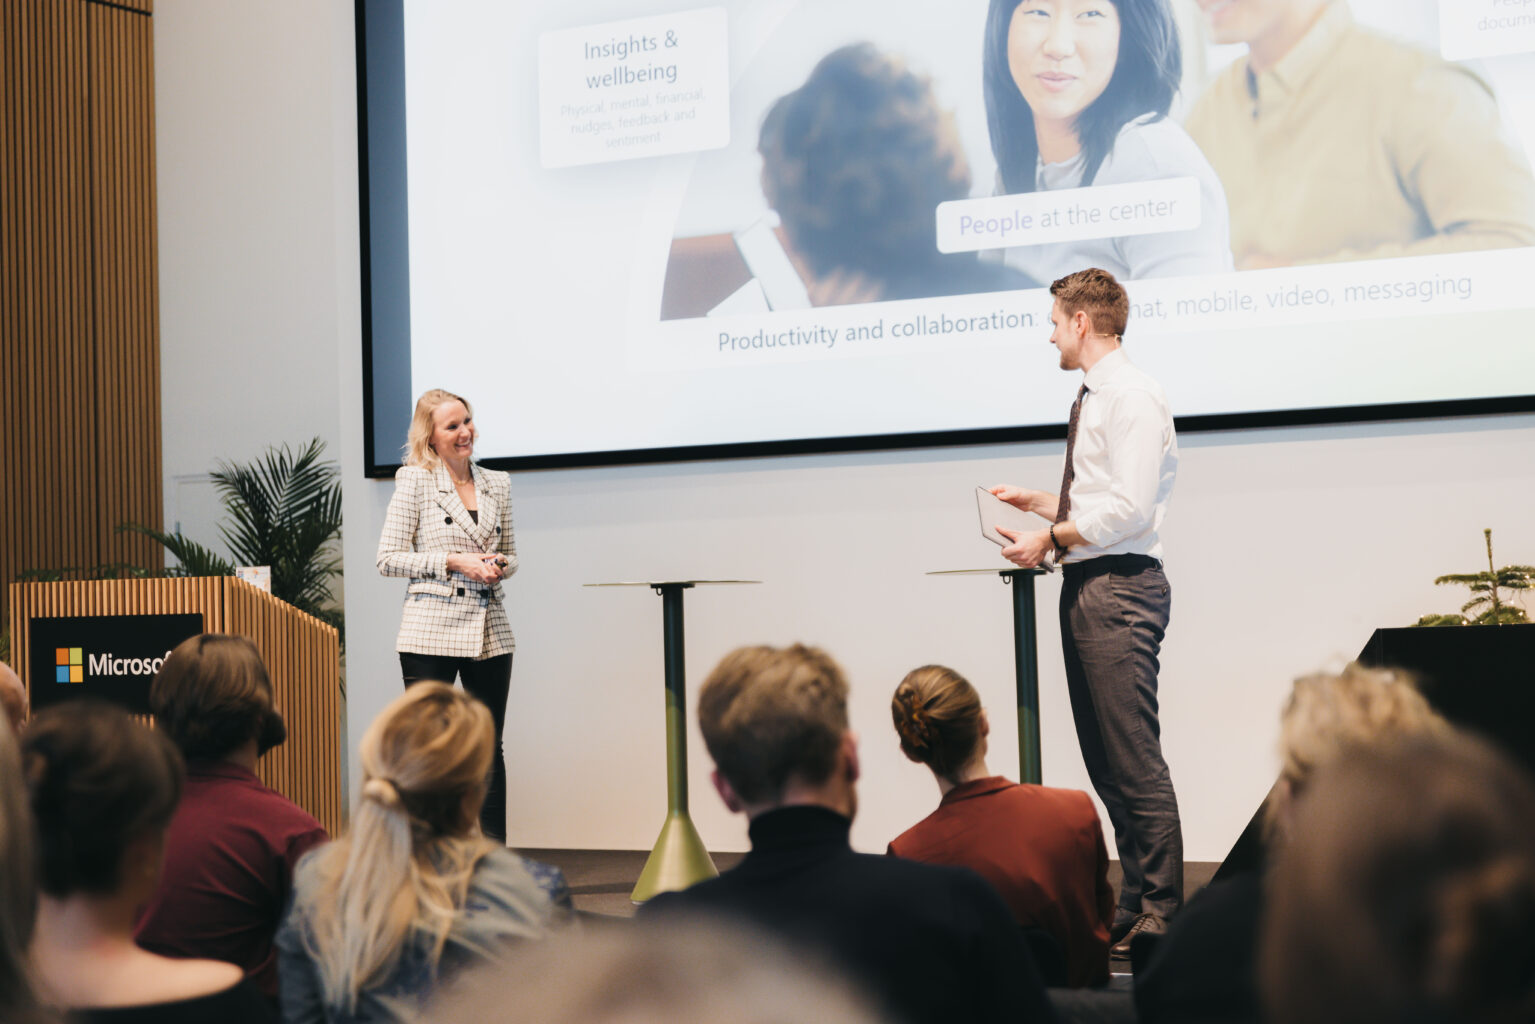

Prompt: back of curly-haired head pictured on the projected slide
xmin=758 ymin=43 xmax=970 ymax=298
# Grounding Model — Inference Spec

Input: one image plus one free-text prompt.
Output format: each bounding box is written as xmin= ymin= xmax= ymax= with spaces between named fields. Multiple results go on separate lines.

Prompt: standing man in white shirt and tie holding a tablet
xmin=992 ymin=269 xmax=1183 ymax=956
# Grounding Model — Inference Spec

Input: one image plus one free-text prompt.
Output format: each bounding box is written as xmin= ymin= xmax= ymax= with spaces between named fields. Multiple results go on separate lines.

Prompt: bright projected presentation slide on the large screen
xmin=377 ymin=0 xmax=1535 ymax=461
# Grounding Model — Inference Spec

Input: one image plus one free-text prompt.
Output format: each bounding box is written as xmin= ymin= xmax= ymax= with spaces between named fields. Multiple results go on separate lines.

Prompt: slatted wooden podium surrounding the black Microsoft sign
xmin=11 ymin=576 xmax=345 ymax=835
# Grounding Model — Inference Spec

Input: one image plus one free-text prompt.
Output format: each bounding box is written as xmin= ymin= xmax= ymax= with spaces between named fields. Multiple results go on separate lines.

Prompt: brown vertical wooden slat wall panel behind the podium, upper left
xmin=0 ymin=0 xmax=163 ymax=641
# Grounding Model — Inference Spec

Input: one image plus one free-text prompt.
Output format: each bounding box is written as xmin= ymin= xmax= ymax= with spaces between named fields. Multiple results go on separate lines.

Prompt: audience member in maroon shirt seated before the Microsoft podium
xmin=135 ymin=633 xmax=328 ymax=999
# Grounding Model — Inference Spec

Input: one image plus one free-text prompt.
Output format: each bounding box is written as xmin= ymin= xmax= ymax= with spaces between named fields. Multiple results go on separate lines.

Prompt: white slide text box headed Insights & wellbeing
xmin=539 ymin=8 xmax=731 ymax=167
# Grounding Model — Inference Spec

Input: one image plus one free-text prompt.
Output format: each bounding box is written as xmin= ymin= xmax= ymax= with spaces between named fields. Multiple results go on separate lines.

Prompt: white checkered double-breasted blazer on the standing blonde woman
xmin=378 ymin=464 xmax=517 ymax=659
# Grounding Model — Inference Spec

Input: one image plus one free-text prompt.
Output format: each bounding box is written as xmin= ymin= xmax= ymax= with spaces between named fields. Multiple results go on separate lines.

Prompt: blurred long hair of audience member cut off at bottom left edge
xmin=0 ymin=722 xmax=37 ymax=1021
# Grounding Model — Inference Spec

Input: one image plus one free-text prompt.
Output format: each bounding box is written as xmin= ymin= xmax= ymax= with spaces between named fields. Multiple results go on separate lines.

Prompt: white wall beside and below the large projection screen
xmin=155 ymin=0 xmax=1535 ymax=860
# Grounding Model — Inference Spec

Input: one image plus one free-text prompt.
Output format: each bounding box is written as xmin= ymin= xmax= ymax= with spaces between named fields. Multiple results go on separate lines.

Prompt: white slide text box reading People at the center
xmin=938 ymin=178 xmax=1200 ymax=252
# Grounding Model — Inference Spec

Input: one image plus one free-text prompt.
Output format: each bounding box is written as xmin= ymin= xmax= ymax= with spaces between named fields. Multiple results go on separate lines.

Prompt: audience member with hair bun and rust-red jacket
xmin=887 ymin=665 xmax=1114 ymax=987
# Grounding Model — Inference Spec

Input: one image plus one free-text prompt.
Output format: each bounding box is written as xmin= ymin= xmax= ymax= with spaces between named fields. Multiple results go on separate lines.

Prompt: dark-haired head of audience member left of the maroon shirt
xmin=21 ymin=700 xmax=183 ymax=897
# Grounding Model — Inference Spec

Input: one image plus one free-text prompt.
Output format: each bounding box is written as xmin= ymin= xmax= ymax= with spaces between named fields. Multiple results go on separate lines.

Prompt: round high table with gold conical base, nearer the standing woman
xmin=585 ymin=580 xmax=761 ymax=903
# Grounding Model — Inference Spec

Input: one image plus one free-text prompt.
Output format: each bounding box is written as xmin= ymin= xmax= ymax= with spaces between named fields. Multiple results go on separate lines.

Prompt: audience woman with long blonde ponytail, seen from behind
xmin=278 ymin=683 xmax=556 ymax=1024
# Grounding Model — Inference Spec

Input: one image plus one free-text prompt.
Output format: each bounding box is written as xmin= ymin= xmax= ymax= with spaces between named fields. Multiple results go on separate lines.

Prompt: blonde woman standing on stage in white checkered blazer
xmin=378 ymin=388 xmax=517 ymax=840
